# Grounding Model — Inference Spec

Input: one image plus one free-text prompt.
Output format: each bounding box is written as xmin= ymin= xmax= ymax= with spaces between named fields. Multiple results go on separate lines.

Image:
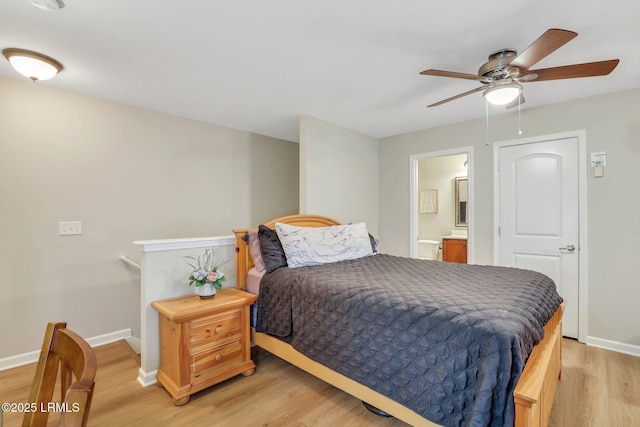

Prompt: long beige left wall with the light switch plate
xmin=0 ymin=78 xmax=298 ymax=358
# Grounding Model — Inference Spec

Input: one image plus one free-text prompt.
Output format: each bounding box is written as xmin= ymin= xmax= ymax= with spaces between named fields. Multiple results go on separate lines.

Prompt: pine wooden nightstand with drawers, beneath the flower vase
xmin=151 ymin=288 xmax=257 ymax=405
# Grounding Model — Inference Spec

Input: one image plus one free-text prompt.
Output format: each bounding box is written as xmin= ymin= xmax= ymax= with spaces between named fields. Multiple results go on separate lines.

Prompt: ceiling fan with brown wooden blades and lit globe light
xmin=420 ymin=28 xmax=620 ymax=108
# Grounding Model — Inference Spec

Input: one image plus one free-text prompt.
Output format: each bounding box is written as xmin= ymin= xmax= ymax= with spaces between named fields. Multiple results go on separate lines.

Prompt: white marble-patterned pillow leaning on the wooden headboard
xmin=276 ymin=222 xmax=373 ymax=267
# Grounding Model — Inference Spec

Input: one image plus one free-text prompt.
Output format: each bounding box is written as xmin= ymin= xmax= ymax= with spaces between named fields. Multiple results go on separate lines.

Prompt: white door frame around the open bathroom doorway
xmin=409 ymin=146 xmax=475 ymax=264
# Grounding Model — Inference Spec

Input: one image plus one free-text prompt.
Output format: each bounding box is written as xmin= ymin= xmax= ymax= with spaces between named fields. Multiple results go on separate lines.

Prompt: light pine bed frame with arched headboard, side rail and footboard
xmin=234 ymin=215 xmax=566 ymax=427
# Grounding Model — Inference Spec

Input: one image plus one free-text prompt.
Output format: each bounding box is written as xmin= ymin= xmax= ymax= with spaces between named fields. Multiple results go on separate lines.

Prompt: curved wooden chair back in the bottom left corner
xmin=22 ymin=322 xmax=97 ymax=427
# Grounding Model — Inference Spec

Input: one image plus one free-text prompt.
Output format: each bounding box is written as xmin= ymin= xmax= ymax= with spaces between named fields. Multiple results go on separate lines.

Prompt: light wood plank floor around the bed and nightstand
xmin=0 ymin=340 xmax=640 ymax=427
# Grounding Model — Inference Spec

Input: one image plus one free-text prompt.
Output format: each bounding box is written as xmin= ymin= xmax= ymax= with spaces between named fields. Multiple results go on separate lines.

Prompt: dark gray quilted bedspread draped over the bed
xmin=256 ymin=254 xmax=562 ymax=426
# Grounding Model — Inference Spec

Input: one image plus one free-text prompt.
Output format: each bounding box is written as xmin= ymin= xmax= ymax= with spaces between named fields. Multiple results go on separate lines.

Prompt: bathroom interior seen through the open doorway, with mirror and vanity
xmin=409 ymin=147 xmax=473 ymax=263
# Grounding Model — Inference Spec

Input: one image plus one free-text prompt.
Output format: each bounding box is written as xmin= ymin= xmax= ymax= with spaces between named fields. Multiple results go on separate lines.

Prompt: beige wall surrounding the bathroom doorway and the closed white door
xmin=379 ymin=89 xmax=640 ymax=352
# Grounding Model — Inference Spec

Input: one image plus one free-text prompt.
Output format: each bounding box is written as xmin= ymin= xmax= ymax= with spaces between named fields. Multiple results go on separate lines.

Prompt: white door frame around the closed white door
xmin=493 ymin=129 xmax=589 ymax=343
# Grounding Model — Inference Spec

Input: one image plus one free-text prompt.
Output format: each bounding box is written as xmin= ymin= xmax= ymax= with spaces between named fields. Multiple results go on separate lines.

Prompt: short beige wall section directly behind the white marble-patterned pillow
xmin=300 ymin=116 xmax=378 ymax=235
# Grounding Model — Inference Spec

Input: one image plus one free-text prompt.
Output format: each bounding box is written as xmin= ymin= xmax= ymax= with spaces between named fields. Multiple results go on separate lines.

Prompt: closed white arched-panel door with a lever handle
xmin=498 ymin=137 xmax=580 ymax=338
